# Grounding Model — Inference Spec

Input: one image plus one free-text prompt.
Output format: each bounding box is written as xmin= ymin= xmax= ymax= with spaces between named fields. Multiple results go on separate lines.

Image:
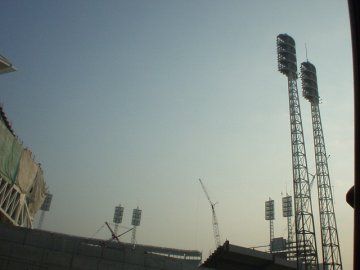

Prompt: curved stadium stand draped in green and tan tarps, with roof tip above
xmin=0 ymin=55 xmax=46 ymax=228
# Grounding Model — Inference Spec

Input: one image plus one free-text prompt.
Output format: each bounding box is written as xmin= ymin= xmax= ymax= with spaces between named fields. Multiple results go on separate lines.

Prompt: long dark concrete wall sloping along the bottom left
xmin=0 ymin=224 xmax=201 ymax=270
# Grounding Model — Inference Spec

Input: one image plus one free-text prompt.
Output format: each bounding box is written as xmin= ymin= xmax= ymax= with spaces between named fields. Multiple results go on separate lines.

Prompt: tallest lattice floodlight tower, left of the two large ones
xmin=277 ymin=34 xmax=319 ymax=269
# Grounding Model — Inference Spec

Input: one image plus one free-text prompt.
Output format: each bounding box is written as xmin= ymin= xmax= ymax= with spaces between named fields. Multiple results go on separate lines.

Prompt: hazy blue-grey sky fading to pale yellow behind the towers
xmin=0 ymin=0 xmax=354 ymax=269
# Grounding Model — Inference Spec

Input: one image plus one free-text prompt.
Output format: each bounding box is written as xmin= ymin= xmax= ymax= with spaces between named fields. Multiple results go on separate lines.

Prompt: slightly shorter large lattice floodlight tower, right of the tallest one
xmin=301 ymin=61 xmax=342 ymax=270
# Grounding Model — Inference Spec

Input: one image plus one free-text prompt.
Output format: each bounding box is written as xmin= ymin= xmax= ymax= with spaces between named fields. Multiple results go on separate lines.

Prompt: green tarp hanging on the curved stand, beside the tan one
xmin=0 ymin=120 xmax=23 ymax=183
